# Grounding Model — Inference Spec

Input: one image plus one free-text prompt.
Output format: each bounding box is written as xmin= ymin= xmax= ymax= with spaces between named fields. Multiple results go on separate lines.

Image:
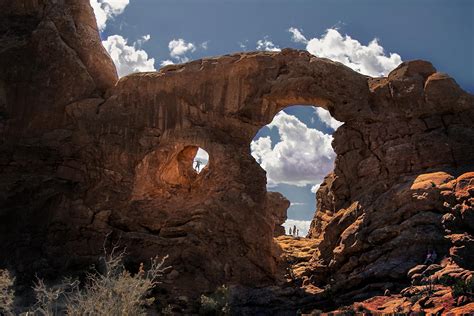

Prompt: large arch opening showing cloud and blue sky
xmin=250 ymin=105 xmax=342 ymax=237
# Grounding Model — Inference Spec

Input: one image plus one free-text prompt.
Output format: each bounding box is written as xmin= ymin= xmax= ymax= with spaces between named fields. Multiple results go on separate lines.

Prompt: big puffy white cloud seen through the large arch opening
xmin=250 ymin=111 xmax=335 ymax=187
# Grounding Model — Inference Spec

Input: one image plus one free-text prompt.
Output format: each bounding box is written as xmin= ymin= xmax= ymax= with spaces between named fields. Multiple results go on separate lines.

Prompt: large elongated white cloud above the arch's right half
xmin=289 ymin=27 xmax=402 ymax=77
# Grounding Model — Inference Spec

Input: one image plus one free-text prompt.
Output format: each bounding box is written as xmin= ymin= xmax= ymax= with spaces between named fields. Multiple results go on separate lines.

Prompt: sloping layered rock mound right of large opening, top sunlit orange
xmin=306 ymin=169 xmax=474 ymax=297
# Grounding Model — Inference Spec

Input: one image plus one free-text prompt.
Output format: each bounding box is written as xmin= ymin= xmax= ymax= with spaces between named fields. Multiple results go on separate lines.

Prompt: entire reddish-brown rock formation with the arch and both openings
xmin=0 ymin=0 xmax=474 ymax=302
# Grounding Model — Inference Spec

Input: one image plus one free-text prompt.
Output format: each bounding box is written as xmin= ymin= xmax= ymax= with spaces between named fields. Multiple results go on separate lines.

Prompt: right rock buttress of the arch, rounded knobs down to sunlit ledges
xmin=309 ymin=61 xmax=474 ymax=296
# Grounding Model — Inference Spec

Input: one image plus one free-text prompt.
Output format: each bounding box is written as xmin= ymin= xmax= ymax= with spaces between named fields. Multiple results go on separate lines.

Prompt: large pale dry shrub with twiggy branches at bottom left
xmin=32 ymin=250 xmax=168 ymax=316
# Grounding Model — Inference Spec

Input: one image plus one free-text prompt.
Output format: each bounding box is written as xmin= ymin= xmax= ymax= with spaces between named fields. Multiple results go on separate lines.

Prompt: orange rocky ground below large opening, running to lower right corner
xmin=266 ymin=236 xmax=474 ymax=315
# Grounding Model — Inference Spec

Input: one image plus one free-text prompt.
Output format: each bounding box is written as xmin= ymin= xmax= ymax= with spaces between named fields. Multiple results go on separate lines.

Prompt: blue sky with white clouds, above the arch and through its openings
xmin=90 ymin=0 xmax=474 ymax=234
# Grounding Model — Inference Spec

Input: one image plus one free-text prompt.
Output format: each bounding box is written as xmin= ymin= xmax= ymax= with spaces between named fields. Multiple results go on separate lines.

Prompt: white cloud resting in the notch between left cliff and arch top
xmin=102 ymin=35 xmax=155 ymax=77
